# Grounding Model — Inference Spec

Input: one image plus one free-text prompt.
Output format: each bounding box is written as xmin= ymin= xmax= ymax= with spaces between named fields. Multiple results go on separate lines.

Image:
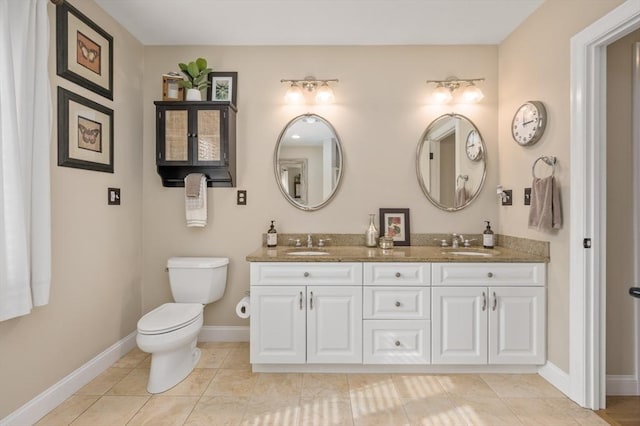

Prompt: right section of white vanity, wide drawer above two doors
xmin=432 ymin=263 xmax=546 ymax=365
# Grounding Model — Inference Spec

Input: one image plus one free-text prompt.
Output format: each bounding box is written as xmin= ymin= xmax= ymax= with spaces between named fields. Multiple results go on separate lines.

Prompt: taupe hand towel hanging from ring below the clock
xmin=529 ymin=176 xmax=562 ymax=230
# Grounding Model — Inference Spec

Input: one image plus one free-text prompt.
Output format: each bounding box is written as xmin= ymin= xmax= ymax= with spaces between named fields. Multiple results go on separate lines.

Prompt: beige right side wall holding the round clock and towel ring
xmin=498 ymin=0 xmax=622 ymax=372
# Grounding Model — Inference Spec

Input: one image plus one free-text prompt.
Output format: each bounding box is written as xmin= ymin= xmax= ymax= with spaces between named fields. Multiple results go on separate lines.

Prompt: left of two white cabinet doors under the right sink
xmin=431 ymin=287 xmax=488 ymax=364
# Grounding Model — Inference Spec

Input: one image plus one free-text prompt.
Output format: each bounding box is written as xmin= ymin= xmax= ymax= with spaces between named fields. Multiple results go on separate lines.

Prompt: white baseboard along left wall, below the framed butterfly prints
xmin=0 ymin=331 xmax=137 ymax=426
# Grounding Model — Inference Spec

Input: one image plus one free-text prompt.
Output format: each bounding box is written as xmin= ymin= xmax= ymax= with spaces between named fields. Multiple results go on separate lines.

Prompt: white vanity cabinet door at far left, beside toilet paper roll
xmin=250 ymin=286 xmax=306 ymax=364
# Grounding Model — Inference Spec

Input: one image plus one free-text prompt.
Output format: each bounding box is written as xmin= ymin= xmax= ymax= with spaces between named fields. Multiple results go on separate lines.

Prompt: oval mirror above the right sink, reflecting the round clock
xmin=416 ymin=113 xmax=487 ymax=211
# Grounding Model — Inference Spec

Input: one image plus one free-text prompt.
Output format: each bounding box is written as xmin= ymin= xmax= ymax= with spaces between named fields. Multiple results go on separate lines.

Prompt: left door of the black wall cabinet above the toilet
xmin=156 ymin=107 xmax=191 ymax=165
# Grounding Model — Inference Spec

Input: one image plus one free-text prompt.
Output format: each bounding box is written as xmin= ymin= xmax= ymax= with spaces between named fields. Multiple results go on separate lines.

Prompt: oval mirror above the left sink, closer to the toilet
xmin=273 ymin=114 xmax=343 ymax=211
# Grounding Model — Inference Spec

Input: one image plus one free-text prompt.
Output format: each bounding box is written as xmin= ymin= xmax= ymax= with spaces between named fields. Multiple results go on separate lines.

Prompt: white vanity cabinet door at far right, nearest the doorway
xmin=489 ymin=287 xmax=546 ymax=364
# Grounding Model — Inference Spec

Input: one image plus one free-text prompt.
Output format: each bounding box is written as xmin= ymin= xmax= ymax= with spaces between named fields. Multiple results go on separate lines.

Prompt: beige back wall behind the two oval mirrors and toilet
xmin=142 ymin=46 xmax=498 ymax=325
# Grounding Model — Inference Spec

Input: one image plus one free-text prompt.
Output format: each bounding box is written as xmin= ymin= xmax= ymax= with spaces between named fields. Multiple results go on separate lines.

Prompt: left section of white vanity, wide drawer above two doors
xmin=250 ymin=262 xmax=362 ymax=364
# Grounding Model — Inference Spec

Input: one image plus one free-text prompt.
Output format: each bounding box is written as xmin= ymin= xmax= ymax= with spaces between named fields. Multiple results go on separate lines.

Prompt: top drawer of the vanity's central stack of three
xmin=364 ymin=262 xmax=431 ymax=286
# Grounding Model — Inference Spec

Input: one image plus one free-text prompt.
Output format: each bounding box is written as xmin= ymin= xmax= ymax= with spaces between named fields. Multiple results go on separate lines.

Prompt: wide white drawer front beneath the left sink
xmin=251 ymin=262 xmax=362 ymax=285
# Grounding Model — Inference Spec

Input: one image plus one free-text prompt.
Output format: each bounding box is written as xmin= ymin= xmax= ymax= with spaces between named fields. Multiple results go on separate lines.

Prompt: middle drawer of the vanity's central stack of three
xmin=363 ymin=287 xmax=431 ymax=319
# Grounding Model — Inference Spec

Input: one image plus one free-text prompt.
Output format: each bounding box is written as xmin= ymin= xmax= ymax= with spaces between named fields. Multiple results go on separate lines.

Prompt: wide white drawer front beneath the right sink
xmin=431 ymin=263 xmax=546 ymax=287
